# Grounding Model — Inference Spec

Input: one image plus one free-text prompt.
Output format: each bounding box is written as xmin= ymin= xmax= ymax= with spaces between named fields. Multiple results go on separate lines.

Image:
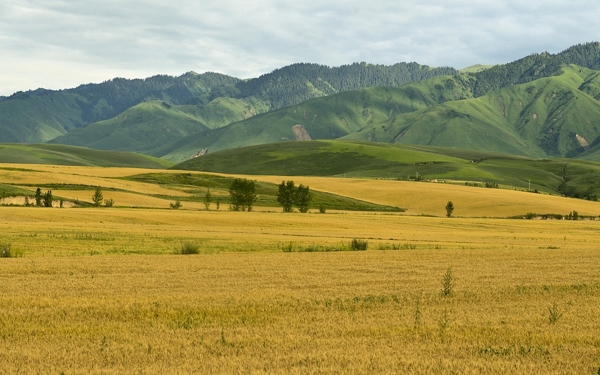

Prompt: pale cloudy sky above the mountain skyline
xmin=0 ymin=0 xmax=600 ymax=95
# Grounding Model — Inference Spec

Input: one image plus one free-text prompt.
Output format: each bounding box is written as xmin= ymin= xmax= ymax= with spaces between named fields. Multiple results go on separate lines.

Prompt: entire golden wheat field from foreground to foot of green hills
xmin=0 ymin=166 xmax=600 ymax=374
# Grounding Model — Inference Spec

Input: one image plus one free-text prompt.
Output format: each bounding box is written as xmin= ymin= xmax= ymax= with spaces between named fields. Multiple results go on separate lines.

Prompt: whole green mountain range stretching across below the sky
xmin=0 ymin=42 xmax=600 ymax=161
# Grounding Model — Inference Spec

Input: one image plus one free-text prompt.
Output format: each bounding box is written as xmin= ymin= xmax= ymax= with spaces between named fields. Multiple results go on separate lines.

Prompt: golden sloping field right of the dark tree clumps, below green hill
xmin=249 ymin=176 xmax=600 ymax=217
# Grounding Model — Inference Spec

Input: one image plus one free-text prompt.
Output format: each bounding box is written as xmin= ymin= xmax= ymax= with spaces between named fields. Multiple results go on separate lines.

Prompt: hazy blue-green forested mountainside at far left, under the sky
xmin=0 ymin=73 xmax=239 ymax=143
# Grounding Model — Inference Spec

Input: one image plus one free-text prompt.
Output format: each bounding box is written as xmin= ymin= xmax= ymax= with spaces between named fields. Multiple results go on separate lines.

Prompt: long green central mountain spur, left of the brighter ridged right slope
xmin=155 ymin=76 xmax=478 ymax=161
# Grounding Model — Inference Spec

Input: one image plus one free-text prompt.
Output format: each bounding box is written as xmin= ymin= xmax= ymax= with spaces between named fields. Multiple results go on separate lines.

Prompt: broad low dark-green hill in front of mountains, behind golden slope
xmin=172 ymin=141 xmax=600 ymax=199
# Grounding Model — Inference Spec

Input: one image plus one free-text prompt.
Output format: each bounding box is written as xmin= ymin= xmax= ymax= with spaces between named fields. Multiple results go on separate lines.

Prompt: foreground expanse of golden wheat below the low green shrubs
xmin=0 ymin=249 xmax=600 ymax=374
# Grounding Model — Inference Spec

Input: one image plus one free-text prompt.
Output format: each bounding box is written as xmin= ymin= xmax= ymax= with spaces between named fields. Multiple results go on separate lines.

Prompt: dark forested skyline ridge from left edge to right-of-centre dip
xmin=0 ymin=63 xmax=456 ymax=145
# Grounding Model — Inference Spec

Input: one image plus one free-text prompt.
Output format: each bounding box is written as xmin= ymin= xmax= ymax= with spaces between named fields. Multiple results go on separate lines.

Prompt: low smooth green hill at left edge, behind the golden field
xmin=0 ymin=144 xmax=172 ymax=168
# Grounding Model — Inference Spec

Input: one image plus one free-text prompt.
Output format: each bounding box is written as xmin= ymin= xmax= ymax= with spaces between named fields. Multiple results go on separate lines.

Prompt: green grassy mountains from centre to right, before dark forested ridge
xmin=159 ymin=66 xmax=600 ymax=161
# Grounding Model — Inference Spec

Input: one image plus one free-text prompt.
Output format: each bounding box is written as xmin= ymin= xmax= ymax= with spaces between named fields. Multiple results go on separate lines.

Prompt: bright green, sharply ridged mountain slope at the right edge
xmin=344 ymin=66 xmax=600 ymax=157
